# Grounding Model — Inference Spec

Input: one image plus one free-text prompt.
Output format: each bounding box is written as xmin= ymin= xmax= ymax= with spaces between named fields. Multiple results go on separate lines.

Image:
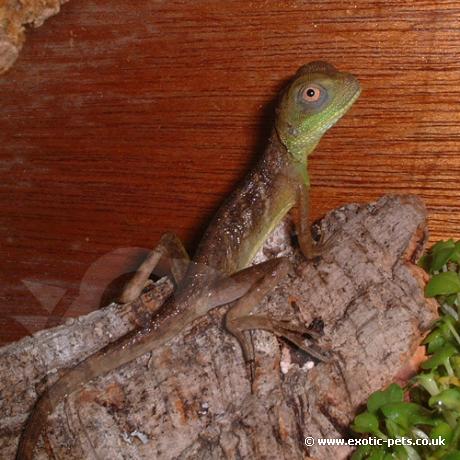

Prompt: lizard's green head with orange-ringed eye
xmin=276 ymin=61 xmax=361 ymax=163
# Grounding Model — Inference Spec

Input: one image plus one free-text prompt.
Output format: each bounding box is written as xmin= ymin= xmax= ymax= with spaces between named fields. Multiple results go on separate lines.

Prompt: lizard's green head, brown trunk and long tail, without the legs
xmin=16 ymin=61 xmax=360 ymax=460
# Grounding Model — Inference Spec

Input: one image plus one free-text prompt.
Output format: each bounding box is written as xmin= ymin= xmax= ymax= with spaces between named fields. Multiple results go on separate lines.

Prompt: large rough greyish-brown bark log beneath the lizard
xmin=0 ymin=196 xmax=436 ymax=459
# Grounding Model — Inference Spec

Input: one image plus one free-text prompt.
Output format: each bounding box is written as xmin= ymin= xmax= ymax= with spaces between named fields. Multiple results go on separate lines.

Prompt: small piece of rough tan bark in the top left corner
xmin=0 ymin=0 xmax=68 ymax=74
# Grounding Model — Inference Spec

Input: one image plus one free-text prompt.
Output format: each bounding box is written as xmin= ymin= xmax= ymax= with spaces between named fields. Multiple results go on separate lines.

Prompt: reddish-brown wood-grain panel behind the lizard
xmin=0 ymin=0 xmax=460 ymax=343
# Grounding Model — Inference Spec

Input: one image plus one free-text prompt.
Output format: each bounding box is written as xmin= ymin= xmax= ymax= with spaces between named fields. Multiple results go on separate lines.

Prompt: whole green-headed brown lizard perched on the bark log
xmin=16 ymin=61 xmax=361 ymax=460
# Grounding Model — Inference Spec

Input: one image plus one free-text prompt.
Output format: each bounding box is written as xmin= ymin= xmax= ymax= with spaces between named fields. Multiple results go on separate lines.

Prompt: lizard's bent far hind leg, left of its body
xmin=119 ymin=233 xmax=190 ymax=303
